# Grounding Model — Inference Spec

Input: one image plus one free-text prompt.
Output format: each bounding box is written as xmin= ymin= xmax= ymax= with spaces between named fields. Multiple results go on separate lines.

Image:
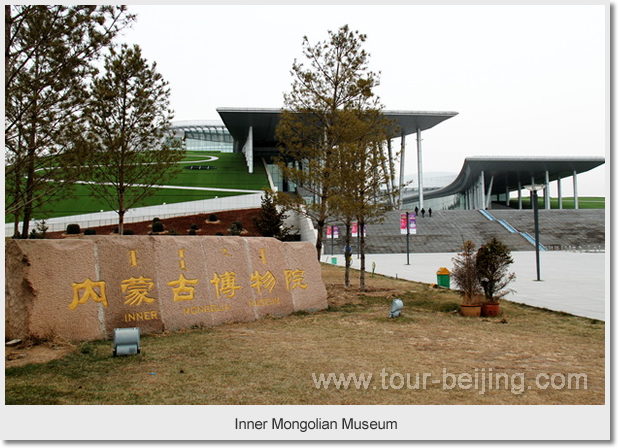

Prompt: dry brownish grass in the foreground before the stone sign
xmin=5 ymin=265 xmax=605 ymax=405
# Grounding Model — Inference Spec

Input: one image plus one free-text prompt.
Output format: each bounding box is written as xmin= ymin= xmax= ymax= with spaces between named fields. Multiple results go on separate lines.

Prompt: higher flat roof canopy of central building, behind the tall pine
xmin=217 ymin=107 xmax=457 ymax=149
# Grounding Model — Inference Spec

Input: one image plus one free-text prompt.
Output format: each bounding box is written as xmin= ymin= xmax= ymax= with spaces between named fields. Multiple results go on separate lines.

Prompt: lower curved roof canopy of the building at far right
xmin=422 ymin=156 xmax=605 ymax=199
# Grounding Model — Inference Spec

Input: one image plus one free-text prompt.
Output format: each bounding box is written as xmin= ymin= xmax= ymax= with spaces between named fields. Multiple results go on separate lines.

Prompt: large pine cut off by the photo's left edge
xmin=5 ymin=5 xmax=134 ymax=238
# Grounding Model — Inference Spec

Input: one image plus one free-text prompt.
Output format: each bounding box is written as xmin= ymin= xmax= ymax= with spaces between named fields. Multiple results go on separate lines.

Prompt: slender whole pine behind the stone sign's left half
xmin=85 ymin=44 xmax=184 ymax=235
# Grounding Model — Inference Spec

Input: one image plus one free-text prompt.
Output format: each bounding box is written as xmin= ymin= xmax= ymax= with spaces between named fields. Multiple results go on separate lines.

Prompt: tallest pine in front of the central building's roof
xmin=276 ymin=25 xmax=379 ymax=259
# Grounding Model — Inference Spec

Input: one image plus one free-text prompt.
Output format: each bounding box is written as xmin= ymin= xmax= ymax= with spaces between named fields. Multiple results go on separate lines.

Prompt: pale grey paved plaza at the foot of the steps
xmin=322 ymin=251 xmax=610 ymax=321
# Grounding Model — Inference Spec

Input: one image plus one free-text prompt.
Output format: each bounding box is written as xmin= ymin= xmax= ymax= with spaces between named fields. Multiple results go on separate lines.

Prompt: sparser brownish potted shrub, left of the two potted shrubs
xmin=451 ymin=240 xmax=483 ymax=317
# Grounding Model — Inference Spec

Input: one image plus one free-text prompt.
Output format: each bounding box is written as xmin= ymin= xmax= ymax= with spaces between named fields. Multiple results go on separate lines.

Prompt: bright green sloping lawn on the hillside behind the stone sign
xmin=5 ymin=151 xmax=269 ymax=222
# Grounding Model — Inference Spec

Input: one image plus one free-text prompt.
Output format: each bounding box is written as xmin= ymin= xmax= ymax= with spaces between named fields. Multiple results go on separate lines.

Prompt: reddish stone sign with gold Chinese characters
xmin=5 ymin=236 xmax=327 ymax=341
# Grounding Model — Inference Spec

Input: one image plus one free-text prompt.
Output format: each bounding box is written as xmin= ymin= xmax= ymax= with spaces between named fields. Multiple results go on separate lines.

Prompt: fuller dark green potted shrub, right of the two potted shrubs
xmin=476 ymin=238 xmax=515 ymax=317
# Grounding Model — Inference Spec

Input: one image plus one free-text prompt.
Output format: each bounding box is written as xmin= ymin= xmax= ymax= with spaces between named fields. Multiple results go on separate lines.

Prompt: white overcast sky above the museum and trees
xmin=116 ymin=5 xmax=609 ymax=195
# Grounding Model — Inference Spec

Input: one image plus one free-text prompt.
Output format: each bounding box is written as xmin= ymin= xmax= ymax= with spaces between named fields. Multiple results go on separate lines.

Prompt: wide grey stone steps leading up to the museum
xmin=322 ymin=210 xmax=605 ymax=255
